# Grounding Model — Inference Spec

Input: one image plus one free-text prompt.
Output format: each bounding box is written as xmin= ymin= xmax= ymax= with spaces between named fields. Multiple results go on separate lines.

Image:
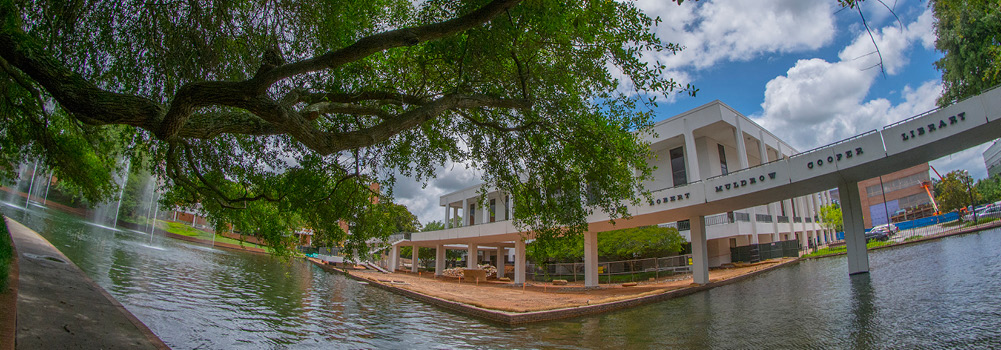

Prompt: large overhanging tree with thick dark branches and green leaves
xmin=0 ymin=0 xmax=696 ymax=253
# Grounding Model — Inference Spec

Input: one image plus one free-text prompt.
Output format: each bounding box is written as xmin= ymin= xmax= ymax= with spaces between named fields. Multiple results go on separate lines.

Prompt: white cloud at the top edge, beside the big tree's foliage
xmin=637 ymin=0 xmax=835 ymax=69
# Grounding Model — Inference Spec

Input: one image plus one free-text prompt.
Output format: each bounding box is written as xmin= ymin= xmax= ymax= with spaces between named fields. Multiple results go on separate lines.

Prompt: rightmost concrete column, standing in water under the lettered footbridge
xmin=838 ymin=181 xmax=869 ymax=275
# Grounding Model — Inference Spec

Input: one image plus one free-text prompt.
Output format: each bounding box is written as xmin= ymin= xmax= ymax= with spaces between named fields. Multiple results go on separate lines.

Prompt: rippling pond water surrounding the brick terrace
xmin=2 ymin=205 xmax=1001 ymax=349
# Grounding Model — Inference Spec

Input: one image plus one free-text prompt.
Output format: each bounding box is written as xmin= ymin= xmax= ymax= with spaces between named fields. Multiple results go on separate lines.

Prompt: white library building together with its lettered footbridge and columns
xmin=393 ymin=88 xmax=1001 ymax=287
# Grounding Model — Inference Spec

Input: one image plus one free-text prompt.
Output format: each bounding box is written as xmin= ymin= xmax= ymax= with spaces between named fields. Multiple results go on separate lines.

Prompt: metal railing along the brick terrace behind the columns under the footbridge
xmin=526 ymin=254 xmax=692 ymax=283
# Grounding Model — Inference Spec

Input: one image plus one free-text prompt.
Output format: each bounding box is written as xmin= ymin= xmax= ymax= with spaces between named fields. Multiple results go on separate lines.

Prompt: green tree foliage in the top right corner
xmin=931 ymin=0 xmax=1001 ymax=105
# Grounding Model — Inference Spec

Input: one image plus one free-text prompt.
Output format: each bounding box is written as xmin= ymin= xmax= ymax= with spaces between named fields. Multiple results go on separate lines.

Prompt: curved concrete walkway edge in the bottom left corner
xmin=4 ymin=217 xmax=169 ymax=349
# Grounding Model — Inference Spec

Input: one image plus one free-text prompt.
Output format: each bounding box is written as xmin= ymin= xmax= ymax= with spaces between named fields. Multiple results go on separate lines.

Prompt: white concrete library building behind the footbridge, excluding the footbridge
xmin=394 ymin=101 xmax=834 ymax=282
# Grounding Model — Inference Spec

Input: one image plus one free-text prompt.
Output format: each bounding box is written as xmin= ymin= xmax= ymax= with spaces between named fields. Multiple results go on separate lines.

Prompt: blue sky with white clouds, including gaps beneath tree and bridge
xmin=393 ymin=0 xmax=990 ymax=223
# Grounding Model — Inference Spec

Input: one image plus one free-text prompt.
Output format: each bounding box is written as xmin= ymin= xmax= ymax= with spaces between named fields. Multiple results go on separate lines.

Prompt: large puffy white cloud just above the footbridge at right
xmin=753 ymin=5 xmax=942 ymax=150
